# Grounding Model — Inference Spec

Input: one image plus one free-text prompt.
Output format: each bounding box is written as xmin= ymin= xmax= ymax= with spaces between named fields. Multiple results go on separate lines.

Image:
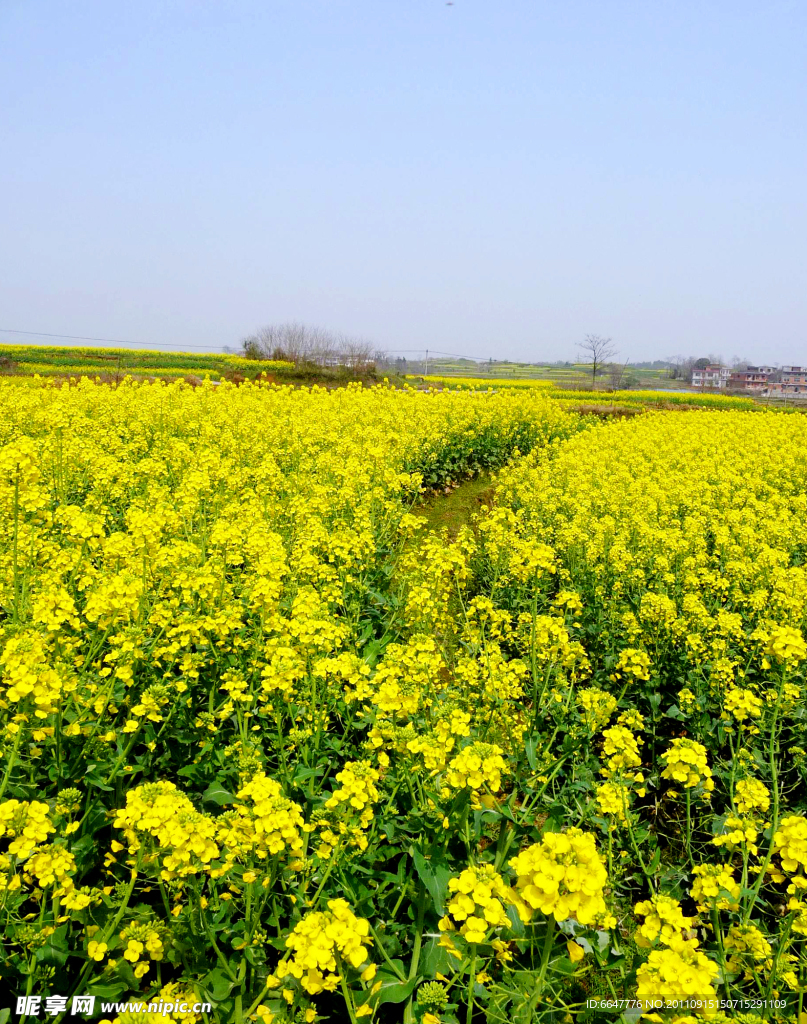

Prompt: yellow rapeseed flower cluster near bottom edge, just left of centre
xmin=274 ymin=899 xmax=372 ymax=995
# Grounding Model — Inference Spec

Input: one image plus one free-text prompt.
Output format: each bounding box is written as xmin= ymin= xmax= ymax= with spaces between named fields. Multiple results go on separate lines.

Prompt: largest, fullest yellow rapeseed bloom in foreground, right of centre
xmin=510 ymin=828 xmax=612 ymax=927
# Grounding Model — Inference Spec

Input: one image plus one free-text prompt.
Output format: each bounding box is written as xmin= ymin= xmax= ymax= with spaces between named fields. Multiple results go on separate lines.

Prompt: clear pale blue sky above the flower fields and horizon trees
xmin=0 ymin=0 xmax=807 ymax=364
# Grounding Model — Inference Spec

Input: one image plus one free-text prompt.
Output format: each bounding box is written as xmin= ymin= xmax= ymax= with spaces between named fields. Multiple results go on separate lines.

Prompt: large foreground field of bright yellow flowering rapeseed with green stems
xmin=0 ymin=379 xmax=807 ymax=1024
